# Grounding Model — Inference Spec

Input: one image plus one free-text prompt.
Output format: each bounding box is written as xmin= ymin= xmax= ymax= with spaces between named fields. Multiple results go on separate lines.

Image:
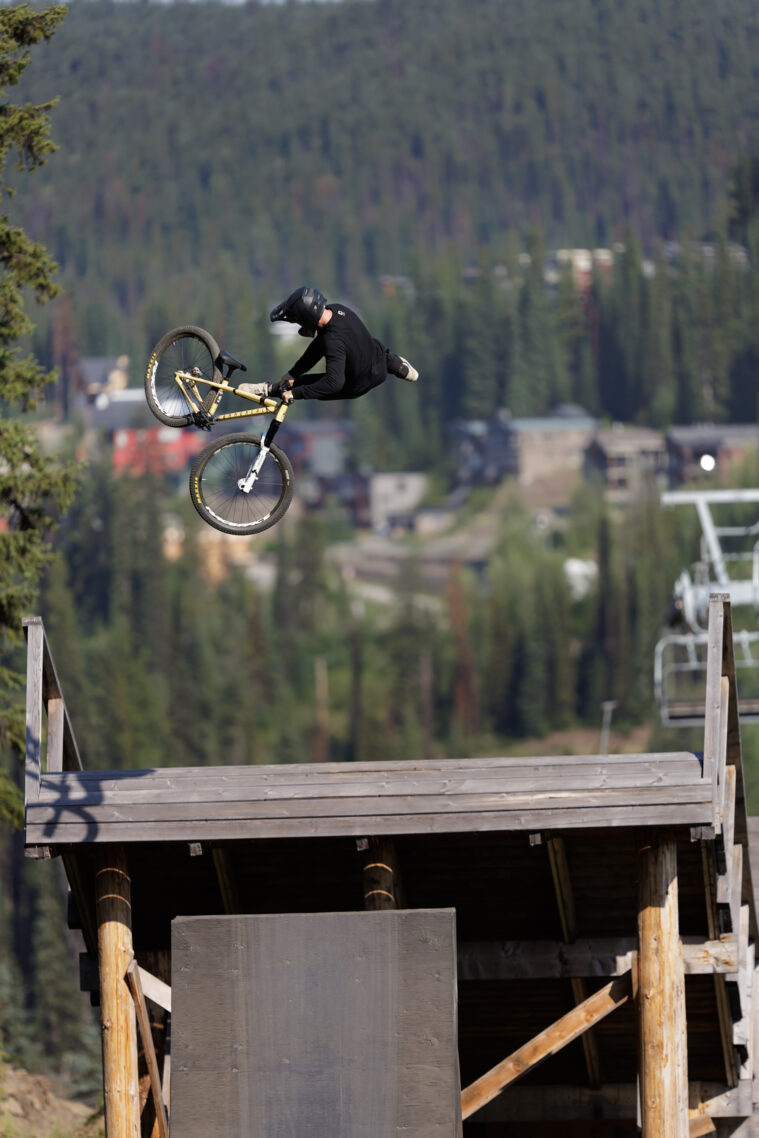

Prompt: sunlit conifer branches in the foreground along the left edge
xmin=0 ymin=3 xmax=73 ymax=822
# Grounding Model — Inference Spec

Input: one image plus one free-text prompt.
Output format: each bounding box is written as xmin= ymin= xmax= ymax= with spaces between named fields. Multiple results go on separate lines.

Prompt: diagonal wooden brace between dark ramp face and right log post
xmin=461 ymin=972 xmax=633 ymax=1119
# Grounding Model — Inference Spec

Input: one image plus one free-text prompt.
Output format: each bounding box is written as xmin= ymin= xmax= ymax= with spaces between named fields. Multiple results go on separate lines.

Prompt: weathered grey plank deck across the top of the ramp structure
xmin=26 ymin=752 xmax=715 ymax=846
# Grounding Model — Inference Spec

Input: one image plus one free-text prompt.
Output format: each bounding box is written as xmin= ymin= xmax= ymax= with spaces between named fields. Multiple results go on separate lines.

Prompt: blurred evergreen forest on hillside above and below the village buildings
xmin=5 ymin=0 xmax=759 ymax=1092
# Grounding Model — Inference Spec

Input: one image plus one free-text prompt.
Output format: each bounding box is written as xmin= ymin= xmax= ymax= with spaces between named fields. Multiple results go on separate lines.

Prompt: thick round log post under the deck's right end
xmin=637 ymin=838 xmax=688 ymax=1138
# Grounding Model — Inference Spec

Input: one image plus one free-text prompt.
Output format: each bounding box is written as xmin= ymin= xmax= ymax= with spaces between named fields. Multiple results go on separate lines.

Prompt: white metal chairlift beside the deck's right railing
xmin=653 ymin=489 xmax=759 ymax=727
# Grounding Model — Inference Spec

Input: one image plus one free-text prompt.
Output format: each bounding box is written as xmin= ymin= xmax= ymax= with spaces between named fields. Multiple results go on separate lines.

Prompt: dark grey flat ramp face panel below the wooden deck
xmin=171 ymin=909 xmax=461 ymax=1138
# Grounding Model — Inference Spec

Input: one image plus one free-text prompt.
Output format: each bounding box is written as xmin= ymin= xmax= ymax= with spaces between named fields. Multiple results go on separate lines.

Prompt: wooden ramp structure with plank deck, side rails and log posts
xmin=20 ymin=596 xmax=757 ymax=1138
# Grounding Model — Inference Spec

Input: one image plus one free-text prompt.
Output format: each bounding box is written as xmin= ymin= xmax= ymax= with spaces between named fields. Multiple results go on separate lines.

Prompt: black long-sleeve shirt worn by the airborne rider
xmin=290 ymin=304 xmax=387 ymax=399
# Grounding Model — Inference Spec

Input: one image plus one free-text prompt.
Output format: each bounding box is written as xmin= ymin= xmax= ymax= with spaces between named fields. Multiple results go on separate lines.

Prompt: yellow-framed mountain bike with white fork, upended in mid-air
xmin=145 ymin=324 xmax=294 ymax=534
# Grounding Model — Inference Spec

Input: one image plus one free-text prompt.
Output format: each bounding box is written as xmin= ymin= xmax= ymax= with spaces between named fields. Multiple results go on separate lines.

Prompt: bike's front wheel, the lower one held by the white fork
xmin=190 ymin=435 xmax=294 ymax=535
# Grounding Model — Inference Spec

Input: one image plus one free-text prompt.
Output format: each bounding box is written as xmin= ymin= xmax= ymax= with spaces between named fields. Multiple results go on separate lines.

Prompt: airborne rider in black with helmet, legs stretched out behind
xmin=238 ymin=288 xmax=419 ymax=403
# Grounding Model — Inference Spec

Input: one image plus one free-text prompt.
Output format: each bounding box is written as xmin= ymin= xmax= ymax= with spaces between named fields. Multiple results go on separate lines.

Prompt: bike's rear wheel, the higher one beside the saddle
xmin=145 ymin=324 xmax=222 ymax=427
